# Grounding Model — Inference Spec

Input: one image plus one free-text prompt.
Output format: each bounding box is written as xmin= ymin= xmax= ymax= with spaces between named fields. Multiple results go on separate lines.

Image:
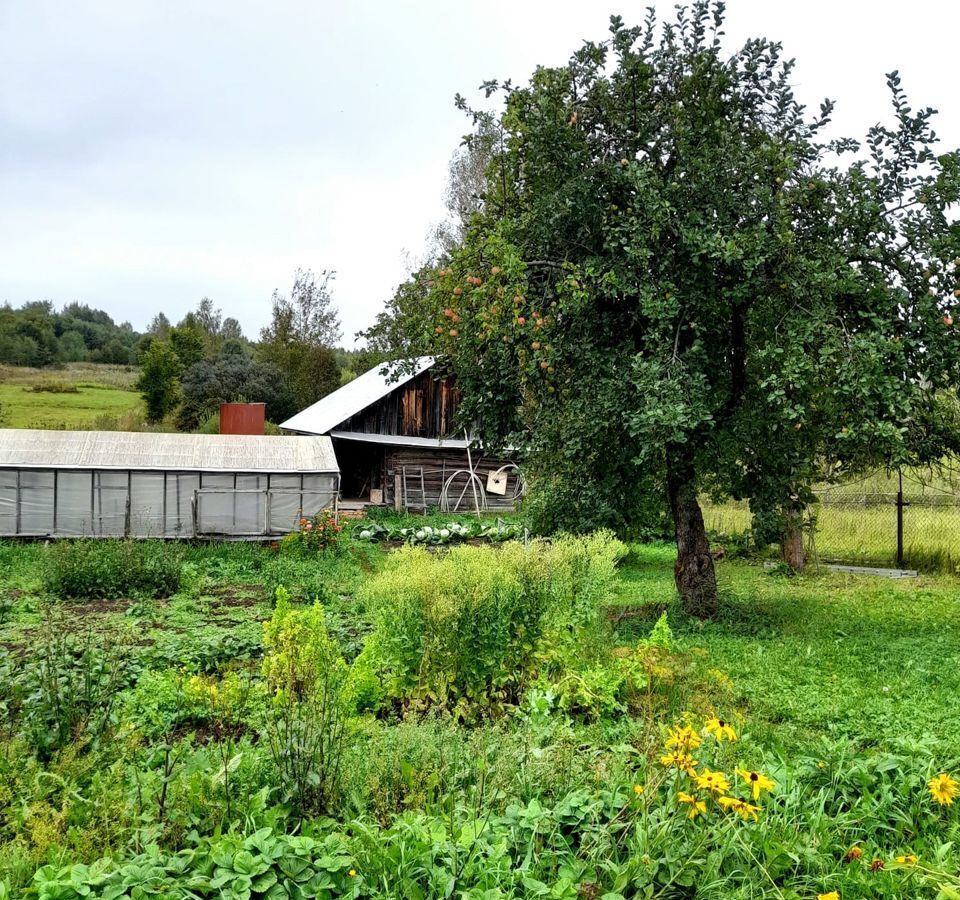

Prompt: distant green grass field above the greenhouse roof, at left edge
xmin=0 ymin=363 xmax=143 ymax=430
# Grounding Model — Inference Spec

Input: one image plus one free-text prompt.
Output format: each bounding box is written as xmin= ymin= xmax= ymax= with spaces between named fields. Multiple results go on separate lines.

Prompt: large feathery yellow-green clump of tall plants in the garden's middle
xmin=360 ymin=533 xmax=624 ymax=716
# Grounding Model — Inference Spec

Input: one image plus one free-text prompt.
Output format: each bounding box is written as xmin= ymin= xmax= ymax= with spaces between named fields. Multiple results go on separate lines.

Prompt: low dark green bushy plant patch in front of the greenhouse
xmin=44 ymin=540 xmax=183 ymax=599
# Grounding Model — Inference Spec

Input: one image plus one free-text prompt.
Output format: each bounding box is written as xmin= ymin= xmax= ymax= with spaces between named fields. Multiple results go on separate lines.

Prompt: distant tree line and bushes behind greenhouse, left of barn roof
xmin=0 ymin=270 xmax=380 ymax=431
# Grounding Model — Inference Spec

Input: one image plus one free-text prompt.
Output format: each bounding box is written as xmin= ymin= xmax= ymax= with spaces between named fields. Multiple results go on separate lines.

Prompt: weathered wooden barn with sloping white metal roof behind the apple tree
xmin=280 ymin=357 xmax=522 ymax=512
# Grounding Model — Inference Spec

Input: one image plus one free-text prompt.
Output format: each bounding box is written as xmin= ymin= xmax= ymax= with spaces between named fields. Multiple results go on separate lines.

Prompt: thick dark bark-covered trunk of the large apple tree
xmin=667 ymin=446 xmax=720 ymax=619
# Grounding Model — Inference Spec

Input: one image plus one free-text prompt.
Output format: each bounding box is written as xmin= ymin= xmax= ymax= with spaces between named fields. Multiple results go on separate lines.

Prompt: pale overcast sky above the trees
xmin=0 ymin=0 xmax=960 ymax=346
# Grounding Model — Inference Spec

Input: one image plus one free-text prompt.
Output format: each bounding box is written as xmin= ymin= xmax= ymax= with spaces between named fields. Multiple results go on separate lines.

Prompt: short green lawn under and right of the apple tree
xmin=617 ymin=546 xmax=960 ymax=755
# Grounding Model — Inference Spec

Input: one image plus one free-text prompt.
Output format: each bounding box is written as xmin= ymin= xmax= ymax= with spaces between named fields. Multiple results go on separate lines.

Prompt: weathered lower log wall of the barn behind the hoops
xmin=383 ymin=447 xmax=517 ymax=512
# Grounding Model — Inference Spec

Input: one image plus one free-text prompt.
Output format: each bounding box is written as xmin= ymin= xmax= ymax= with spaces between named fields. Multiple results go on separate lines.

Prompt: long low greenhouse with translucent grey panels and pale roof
xmin=0 ymin=429 xmax=340 ymax=540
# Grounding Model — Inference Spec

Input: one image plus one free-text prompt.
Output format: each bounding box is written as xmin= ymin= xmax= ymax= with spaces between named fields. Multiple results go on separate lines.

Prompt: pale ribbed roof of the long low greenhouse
xmin=0 ymin=428 xmax=340 ymax=472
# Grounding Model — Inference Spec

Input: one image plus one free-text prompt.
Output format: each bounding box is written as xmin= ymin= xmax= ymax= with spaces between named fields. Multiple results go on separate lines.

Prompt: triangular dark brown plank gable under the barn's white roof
xmin=337 ymin=369 xmax=460 ymax=437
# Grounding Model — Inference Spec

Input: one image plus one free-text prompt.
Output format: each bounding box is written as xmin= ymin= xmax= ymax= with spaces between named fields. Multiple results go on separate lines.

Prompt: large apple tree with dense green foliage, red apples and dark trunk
xmin=368 ymin=2 xmax=960 ymax=616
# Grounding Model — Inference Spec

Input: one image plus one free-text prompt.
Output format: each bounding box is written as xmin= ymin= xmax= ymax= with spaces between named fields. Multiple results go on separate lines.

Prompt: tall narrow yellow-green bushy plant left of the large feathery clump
xmin=263 ymin=597 xmax=348 ymax=816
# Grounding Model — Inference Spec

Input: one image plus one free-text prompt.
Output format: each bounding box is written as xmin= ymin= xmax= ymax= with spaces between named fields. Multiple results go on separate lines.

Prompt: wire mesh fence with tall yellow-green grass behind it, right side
xmin=704 ymin=470 xmax=960 ymax=575
